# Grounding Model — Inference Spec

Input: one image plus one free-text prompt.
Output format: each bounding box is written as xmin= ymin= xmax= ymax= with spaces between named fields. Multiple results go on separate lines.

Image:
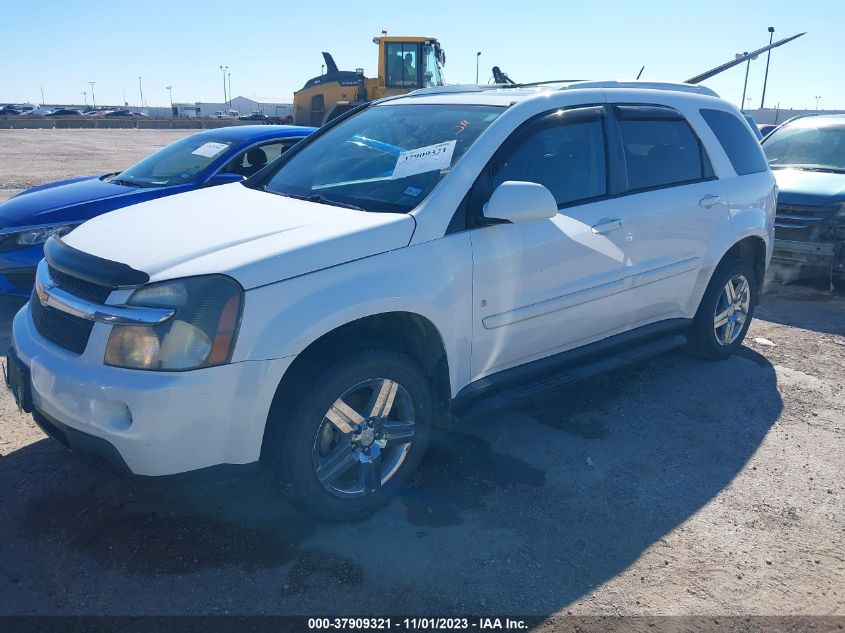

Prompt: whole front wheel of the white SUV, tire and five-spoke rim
xmin=265 ymin=349 xmax=435 ymax=521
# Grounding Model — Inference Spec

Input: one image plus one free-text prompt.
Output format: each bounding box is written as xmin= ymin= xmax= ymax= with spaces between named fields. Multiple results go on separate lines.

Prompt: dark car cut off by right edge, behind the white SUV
xmin=763 ymin=115 xmax=845 ymax=278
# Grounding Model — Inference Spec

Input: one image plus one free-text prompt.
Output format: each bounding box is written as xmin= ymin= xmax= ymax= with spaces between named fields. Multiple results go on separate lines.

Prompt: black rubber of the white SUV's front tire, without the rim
xmin=264 ymin=349 xmax=435 ymax=521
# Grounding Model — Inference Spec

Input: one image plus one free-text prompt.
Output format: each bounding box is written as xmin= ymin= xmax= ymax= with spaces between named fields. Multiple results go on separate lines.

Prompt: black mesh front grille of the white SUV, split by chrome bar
xmin=29 ymin=266 xmax=112 ymax=354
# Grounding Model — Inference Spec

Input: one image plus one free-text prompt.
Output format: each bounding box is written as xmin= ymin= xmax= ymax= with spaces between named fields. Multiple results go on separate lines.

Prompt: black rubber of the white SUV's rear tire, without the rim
xmin=688 ymin=257 xmax=759 ymax=360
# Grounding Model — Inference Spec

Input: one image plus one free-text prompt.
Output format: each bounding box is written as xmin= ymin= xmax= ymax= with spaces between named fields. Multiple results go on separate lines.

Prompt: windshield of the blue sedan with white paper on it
xmin=111 ymin=136 xmax=232 ymax=187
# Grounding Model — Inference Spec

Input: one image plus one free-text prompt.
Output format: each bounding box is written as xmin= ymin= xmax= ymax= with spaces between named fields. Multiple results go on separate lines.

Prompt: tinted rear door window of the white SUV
xmin=619 ymin=118 xmax=710 ymax=189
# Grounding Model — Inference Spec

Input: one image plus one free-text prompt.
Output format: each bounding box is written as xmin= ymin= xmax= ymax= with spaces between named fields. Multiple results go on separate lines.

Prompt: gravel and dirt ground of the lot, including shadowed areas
xmin=0 ymin=130 xmax=845 ymax=616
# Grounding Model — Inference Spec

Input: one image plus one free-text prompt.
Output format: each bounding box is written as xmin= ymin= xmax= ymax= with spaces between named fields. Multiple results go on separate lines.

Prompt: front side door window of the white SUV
xmin=494 ymin=120 xmax=607 ymax=205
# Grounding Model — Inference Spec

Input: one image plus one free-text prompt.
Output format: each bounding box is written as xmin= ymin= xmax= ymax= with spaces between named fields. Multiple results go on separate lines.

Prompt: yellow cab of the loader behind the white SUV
xmin=374 ymin=37 xmax=446 ymax=96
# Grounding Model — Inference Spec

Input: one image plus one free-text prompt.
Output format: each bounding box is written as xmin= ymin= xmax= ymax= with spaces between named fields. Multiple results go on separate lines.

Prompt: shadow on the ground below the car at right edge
xmin=757 ymin=279 xmax=845 ymax=336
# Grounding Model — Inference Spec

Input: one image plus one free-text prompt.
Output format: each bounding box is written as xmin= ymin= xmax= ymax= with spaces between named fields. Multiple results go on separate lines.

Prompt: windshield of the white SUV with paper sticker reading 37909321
xmin=265 ymin=104 xmax=504 ymax=212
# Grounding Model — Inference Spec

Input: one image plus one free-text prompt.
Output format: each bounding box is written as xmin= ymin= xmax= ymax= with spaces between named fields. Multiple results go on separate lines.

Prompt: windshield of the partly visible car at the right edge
xmin=763 ymin=118 xmax=845 ymax=173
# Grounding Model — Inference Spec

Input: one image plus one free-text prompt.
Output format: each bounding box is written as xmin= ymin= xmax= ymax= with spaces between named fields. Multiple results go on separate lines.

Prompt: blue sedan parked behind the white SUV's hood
xmin=0 ymin=125 xmax=314 ymax=296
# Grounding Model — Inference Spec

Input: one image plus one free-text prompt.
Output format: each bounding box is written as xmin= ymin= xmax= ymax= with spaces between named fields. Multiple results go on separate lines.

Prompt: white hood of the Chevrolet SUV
xmin=62 ymin=183 xmax=415 ymax=289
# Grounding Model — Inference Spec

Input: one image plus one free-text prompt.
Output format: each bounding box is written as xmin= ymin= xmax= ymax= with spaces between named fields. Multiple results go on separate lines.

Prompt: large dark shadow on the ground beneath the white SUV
xmin=0 ymin=330 xmax=782 ymax=615
